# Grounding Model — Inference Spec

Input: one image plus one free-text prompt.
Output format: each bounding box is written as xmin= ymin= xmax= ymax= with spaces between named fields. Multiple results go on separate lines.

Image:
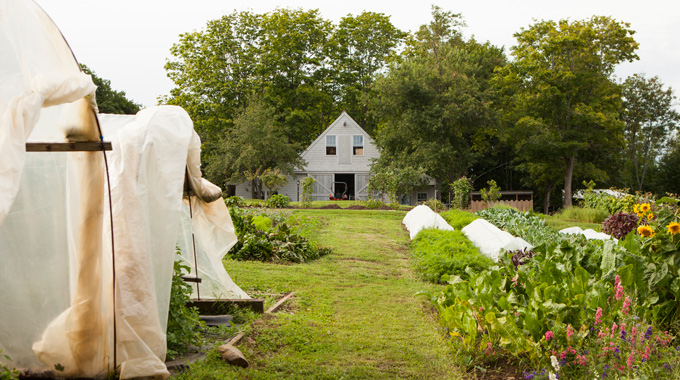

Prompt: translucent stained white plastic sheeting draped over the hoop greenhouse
xmin=0 ymin=0 xmax=247 ymax=379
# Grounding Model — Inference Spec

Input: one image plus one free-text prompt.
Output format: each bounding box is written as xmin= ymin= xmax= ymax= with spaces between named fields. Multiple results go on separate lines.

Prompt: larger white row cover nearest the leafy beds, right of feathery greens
xmin=462 ymin=219 xmax=533 ymax=261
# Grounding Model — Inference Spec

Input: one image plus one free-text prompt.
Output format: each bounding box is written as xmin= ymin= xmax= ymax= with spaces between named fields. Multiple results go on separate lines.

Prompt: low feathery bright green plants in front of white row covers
xmin=411 ymin=229 xmax=493 ymax=283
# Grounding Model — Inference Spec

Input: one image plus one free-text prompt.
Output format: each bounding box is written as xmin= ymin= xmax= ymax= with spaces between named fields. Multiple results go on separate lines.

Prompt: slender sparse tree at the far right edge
xmin=622 ymin=74 xmax=680 ymax=191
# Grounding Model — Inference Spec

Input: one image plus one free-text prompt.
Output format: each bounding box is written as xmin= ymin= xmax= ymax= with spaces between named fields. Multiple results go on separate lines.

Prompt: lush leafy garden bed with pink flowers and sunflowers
xmin=430 ymin=200 xmax=680 ymax=379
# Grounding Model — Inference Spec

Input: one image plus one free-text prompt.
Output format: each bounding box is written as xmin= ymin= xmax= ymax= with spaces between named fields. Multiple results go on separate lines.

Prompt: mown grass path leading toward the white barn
xmin=175 ymin=210 xmax=462 ymax=379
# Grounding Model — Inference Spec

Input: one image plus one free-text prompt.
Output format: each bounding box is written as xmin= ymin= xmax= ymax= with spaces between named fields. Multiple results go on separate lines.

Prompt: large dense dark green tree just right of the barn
xmin=371 ymin=7 xmax=505 ymax=193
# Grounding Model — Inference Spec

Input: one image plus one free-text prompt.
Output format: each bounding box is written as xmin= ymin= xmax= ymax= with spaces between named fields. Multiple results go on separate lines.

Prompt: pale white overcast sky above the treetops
xmin=36 ymin=0 xmax=680 ymax=106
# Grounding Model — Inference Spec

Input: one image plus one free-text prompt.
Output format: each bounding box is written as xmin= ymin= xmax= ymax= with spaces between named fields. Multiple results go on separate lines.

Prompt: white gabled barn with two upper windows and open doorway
xmin=235 ymin=111 xmax=434 ymax=204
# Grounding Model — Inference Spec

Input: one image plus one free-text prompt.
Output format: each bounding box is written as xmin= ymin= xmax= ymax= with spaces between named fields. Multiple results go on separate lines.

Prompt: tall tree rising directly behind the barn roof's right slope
xmin=329 ymin=12 xmax=407 ymax=133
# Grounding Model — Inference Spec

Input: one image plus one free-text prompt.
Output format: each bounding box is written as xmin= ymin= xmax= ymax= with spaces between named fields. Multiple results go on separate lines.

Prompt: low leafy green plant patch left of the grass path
xmin=228 ymin=208 xmax=332 ymax=263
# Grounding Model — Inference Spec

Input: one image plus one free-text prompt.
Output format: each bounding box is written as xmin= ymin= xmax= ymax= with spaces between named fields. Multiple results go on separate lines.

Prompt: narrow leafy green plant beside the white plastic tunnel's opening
xmin=167 ymin=250 xmax=204 ymax=358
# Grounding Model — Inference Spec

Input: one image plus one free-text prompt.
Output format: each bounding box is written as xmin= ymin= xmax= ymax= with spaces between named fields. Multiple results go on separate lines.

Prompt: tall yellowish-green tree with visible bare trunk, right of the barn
xmin=496 ymin=17 xmax=638 ymax=206
